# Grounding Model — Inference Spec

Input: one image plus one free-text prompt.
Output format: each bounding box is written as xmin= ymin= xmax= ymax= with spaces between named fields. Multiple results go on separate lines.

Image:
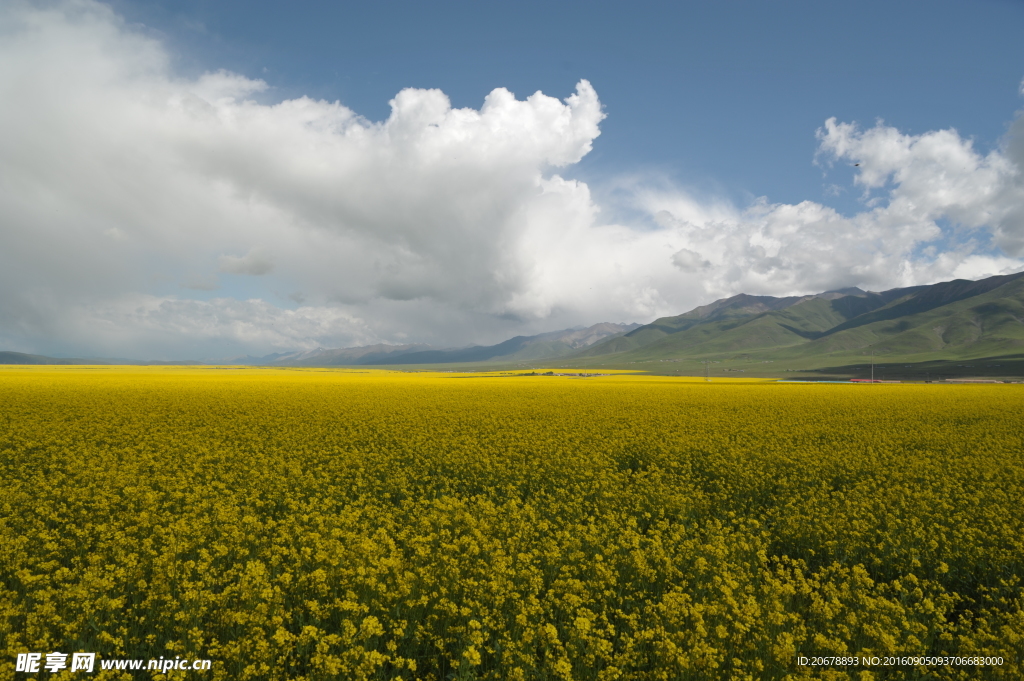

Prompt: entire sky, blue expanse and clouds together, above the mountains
xmin=0 ymin=0 xmax=1024 ymax=358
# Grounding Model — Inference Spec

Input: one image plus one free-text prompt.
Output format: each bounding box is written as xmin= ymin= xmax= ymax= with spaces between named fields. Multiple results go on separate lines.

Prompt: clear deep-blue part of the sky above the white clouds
xmin=115 ymin=0 xmax=1024 ymax=211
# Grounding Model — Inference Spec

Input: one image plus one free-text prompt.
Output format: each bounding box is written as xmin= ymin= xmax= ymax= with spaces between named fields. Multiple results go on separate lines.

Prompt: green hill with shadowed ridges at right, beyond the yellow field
xmin=573 ymin=272 xmax=1024 ymax=364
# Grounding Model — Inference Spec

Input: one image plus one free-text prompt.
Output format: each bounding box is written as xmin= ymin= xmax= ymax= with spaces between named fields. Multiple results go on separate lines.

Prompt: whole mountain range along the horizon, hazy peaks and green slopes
xmin=8 ymin=272 xmax=1024 ymax=367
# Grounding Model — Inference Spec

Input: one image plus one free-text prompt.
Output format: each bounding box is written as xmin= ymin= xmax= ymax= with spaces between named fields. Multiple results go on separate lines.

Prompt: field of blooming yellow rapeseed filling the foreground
xmin=0 ymin=367 xmax=1024 ymax=681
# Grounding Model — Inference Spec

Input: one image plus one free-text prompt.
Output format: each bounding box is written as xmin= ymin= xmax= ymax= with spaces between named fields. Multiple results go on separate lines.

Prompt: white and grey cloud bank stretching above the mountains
xmin=0 ymin=0 xmax=1024 ymax=357
